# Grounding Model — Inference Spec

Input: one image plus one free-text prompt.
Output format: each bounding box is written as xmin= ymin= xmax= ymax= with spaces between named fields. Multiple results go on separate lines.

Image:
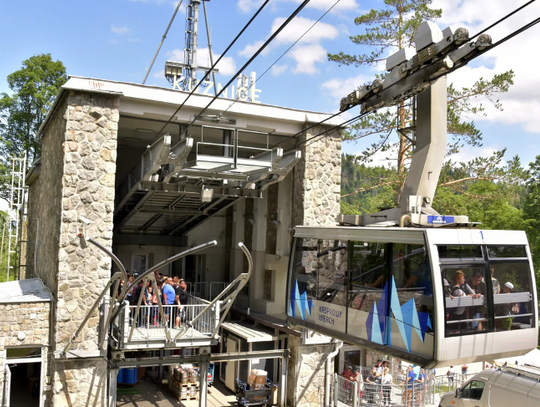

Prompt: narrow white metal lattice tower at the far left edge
xmin=6 ymin=153 xmax=26 ymax=281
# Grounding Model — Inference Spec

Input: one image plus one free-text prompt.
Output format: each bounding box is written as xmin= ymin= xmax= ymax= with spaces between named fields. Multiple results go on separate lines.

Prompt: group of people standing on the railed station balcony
xmin=117 ymin=272 xmax=189 ymax=328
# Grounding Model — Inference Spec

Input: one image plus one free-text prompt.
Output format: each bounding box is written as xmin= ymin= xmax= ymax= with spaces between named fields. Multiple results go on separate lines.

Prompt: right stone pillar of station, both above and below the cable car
xmin=287 ymin=125 xmax=341 ymax=407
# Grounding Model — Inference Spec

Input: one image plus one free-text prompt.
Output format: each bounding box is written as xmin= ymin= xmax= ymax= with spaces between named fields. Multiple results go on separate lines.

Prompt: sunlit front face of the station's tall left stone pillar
xmin=54 ymin=92 xmax=119 ymax=350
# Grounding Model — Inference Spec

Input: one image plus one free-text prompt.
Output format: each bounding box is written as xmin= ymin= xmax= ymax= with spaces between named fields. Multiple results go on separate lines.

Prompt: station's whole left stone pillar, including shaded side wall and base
xmin=28 ymin=91 xmax=119 ymax=407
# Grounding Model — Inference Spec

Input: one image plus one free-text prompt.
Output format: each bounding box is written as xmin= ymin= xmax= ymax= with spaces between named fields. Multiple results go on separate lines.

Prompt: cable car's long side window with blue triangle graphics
xmin=288 ymin=238 xmax=434 ymax=355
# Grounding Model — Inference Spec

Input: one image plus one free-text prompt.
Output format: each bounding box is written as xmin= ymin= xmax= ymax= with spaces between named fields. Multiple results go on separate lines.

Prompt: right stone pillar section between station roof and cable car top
xmin=291 ymin=125 xmax=341 ymax=227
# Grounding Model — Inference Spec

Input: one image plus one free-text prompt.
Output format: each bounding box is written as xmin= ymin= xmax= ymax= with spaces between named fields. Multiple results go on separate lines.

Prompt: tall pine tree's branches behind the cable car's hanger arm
xmin=328 ymin=0 xmax=514 ymax=194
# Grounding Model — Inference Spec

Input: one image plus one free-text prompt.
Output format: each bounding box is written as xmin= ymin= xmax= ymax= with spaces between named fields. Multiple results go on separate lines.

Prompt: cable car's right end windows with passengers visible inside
xmin=438 ymin=245 xmax=535 ymax=337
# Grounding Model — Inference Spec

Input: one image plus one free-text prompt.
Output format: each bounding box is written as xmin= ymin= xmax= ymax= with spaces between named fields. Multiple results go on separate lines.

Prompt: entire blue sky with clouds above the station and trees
xmin=0 ymin=0 xmax=540 ymax=169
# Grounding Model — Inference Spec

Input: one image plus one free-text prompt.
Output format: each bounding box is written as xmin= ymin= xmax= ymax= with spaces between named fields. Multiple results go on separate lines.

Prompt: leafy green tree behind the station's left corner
xmin=0 ymin=54 xmax=67 ymax=164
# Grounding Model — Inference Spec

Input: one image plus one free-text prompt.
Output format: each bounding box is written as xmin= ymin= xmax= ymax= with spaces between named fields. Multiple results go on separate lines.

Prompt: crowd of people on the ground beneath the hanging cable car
xmin=342 ymin=360 xmax=427 ymax=407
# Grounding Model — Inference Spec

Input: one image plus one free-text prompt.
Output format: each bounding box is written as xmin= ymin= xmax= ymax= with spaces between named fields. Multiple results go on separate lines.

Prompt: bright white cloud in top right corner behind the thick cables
xmin=432 ymin=0 xmax=540 ymax=133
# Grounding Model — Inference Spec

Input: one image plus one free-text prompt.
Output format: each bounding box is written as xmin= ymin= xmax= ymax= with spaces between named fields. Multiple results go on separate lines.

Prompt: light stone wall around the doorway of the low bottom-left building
xmin=0 ymin=302 xmax=50 ymax=405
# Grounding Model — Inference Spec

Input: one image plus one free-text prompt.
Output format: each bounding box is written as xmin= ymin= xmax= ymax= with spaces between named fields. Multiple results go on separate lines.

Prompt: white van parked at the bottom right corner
xmin=439 ymin=365 xmax=540 ymax=407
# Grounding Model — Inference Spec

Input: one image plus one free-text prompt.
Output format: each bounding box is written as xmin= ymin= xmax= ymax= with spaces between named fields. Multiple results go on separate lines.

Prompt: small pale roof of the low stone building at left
xmin=0 ymin=278 xmax=53 ymax=304
